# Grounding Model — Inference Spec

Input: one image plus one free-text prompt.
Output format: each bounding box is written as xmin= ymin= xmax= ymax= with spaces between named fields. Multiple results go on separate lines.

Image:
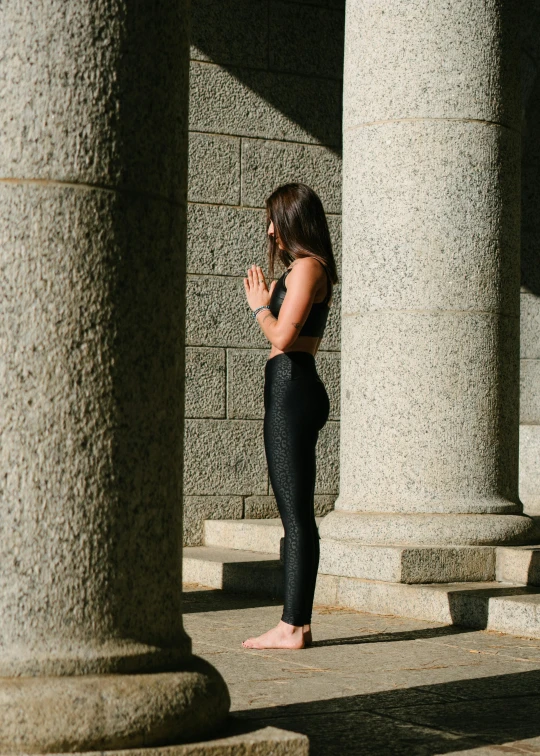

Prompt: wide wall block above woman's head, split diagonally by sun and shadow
xmin=189 ymin=61 xmax=341 ymax=146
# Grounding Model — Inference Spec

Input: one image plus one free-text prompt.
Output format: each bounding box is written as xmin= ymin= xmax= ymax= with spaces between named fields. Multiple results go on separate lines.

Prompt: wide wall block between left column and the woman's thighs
xmin=184 ymin=420 xmax=268 ymax=496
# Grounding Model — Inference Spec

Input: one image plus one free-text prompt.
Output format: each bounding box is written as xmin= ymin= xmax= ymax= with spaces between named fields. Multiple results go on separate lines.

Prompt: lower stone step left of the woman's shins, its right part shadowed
xmin=182 ymin=544 xmax=283 ymax=598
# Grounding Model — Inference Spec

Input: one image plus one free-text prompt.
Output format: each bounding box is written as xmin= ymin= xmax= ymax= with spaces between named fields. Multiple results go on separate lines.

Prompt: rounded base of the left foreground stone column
xmin=0 ymin=657 xmax=230 ymax=754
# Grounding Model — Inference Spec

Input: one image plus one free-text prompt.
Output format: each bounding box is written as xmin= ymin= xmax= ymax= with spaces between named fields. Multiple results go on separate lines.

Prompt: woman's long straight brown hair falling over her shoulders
xmin=266 ymin=183 xmax=339 ymax=284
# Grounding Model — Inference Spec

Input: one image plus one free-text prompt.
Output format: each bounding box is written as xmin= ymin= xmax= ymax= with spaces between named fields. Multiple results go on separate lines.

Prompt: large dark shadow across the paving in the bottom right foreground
xmin=234 ymin=670 xmax=540 ymax=756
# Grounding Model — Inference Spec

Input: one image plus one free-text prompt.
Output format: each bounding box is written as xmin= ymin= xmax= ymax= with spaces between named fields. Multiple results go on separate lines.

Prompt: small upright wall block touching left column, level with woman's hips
xmin=185 ymin=347 xmax=226 ymax=418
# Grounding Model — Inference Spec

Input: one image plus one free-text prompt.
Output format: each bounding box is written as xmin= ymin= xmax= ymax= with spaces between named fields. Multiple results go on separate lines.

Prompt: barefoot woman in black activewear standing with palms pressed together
xmin=243 ymin=184 xmax=338 ymax=649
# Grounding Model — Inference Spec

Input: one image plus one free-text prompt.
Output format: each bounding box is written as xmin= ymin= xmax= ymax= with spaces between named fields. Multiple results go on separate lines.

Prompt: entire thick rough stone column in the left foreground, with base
xmin=0 ymin=0 xmax=229 ymax=752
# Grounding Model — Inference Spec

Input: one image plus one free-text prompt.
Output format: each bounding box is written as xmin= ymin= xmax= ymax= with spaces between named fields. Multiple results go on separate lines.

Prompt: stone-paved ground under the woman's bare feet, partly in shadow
xmin=184 ymin=586 xmax=540 ymax=756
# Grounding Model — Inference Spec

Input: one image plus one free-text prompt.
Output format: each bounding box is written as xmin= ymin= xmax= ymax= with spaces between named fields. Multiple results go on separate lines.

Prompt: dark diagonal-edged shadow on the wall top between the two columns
xmin=191 ymin=0 xmax=345 ymax=153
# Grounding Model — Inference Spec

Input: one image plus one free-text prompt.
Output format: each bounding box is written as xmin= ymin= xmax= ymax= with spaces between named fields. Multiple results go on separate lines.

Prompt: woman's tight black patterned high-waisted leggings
xmin=264 ymin=352 xmax=330 ymax=626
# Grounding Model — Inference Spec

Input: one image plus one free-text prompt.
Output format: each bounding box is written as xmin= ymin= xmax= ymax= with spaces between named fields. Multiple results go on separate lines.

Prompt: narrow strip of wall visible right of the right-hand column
xmin=519 ymin=1 xmax=540 ymax=515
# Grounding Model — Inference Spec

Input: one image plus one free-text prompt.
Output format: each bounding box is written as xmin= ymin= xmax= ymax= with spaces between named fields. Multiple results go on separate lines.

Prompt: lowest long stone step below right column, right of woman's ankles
xmin=315 ymin=574 xmax=540 ymax=638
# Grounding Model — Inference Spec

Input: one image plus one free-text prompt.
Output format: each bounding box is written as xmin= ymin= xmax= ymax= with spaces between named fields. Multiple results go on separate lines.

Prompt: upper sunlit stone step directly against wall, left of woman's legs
xmin=203 ymin=519 xmax=283 ymax=556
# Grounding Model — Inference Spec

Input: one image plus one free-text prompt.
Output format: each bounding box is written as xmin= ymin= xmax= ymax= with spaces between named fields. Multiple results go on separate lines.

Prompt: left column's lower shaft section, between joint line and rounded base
xmin=0 ymin=184 xmax=194 ymax=674
